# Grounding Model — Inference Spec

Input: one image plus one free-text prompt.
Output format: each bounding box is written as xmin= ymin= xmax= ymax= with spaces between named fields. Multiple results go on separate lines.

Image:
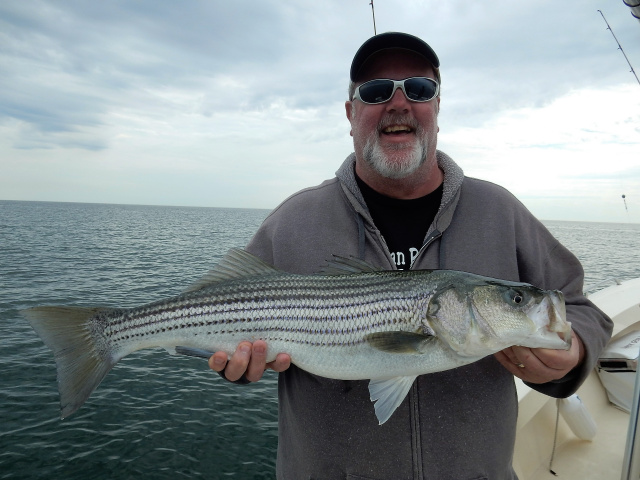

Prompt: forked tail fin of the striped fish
xmin=20 ymin=307 xmax=119 ymax=418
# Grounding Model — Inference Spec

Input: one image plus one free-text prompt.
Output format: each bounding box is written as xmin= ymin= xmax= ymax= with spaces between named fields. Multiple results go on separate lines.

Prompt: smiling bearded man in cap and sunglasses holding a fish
xmin=209 ymin=33 xmax=612 ymax=480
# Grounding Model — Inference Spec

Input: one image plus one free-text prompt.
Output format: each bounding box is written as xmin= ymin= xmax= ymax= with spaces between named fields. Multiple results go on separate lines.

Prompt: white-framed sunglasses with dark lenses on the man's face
xmin=353 ymin=77 xmax=440 ymax=105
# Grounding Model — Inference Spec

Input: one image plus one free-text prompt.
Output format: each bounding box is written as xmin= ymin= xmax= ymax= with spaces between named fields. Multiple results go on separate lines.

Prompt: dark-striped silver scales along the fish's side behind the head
xmin=105 ymin=274 xmax=424 ymax=358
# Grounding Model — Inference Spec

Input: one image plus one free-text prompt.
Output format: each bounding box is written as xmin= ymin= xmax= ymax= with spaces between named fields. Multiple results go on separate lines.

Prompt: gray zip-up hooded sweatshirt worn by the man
xmin=247 ymin=151 xmax=612 ymax=480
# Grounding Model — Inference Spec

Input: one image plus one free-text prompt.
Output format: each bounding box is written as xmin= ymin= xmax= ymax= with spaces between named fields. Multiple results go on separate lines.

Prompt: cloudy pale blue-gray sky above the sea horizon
xmin=0 ymin=0 xmax=640 ymax=222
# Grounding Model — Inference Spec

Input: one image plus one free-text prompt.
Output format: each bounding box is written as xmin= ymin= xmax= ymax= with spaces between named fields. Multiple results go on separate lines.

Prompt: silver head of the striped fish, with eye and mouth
xmin=425 ymin=276 xmax=571 ymax=357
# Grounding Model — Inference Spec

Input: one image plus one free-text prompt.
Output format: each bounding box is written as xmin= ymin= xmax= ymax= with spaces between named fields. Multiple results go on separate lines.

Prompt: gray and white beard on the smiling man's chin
xmin=362 ymin=132 xmax=428 ymax=179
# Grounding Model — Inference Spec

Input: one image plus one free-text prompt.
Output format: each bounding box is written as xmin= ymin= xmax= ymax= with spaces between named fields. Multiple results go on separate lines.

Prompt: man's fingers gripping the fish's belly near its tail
xmin=209 ymin=340 xmax=291 ymax=382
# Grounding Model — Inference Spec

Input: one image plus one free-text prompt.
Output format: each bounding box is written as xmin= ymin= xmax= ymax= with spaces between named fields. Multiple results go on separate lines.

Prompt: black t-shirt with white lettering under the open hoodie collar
xmin=356 ymin=175 xmax=442 ymax=270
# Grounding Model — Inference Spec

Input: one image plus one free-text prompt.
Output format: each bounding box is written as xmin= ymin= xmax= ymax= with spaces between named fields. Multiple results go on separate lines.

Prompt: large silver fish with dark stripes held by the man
xmin=21 ymin=249 xmax=571 ymax=424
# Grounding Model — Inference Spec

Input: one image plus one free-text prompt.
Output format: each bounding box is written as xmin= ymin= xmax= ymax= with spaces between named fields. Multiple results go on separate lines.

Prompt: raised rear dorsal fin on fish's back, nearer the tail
xmin=185 ymin=248 xmax=280 ymax=292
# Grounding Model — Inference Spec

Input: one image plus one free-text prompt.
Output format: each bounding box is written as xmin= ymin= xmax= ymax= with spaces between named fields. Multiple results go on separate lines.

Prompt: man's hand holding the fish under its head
xmin=495 ymin=331 xmax=584 ymax=383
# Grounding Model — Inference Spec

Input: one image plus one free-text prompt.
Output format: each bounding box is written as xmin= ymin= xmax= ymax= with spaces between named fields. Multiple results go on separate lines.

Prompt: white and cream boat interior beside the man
xmin=513 ymin=278 xmax=640 ymax=480
